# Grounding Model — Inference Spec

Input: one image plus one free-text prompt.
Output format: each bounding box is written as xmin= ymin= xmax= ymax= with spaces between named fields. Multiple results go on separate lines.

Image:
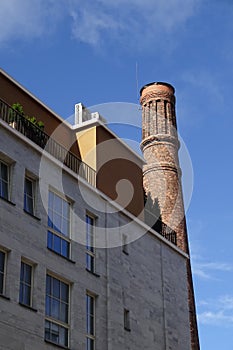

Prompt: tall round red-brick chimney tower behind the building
xmin=140 ymin=82 xmax=200 ymax=350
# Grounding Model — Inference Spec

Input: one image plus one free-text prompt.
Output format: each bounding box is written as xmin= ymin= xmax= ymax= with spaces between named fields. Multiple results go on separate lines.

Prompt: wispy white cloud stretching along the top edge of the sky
xmin=0 ymin=0 xmax=201 ymax=48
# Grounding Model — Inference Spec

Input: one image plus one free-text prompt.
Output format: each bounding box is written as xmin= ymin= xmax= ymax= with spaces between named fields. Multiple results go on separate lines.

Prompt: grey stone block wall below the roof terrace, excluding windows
xmin=0 ymin=121 xmax=190 ymax=350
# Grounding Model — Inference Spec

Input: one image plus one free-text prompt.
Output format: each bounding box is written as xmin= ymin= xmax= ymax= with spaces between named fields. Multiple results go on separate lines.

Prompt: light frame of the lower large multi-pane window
xmin=44 ymin=272 xmax=71 ymax=348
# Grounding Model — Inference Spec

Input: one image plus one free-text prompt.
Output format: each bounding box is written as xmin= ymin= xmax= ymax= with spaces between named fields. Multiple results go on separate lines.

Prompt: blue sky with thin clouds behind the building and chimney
xmin=0 ymin=0 xmax=233 ymax=350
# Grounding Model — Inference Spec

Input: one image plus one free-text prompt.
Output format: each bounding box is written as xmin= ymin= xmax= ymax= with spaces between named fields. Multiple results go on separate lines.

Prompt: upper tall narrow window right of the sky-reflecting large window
xmin=86 ymin=215 xmax=95 ymax=272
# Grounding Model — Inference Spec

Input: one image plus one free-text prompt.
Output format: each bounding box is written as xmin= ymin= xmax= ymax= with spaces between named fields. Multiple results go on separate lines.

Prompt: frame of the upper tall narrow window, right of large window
xmin=85 ymin=212 xmax=97 ymax=273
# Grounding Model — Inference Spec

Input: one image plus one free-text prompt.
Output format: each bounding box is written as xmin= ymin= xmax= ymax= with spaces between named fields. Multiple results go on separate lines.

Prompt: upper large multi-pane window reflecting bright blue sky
xmin=47 ymin=191 xmax=70 ymax=258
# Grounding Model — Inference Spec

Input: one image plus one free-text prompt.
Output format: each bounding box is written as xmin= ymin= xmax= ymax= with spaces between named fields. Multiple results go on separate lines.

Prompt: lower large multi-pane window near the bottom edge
xmin=45 ymin=275 xmax=69 ymax=347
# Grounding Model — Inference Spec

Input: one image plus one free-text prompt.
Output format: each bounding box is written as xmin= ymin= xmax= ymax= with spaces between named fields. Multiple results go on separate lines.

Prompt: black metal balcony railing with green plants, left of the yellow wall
xmin=0 ymin=99 xmax=96 ymax=187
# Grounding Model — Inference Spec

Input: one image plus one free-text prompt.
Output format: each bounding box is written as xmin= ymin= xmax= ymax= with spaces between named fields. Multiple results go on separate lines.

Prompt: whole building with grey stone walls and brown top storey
xmin=0 ymin=71 xmax=197 ymax=350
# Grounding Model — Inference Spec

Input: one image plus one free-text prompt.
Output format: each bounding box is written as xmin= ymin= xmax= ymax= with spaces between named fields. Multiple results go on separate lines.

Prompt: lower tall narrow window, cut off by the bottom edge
xmin=86 ymin=293 xmax=95 ymax=350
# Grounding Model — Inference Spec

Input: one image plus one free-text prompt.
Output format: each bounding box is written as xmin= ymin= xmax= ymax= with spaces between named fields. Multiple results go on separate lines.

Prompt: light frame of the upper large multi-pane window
xmin=47 ymin=188 xmax=72 ymax=259
